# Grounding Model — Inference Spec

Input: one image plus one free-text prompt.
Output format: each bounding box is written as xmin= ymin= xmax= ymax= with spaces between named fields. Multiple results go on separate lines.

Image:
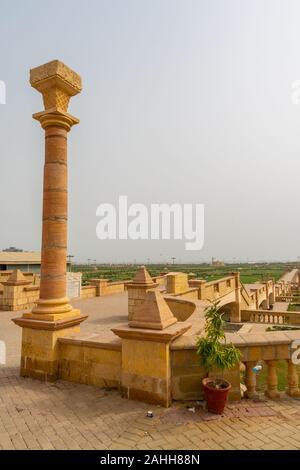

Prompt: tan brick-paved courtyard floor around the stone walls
xmin=0 ymin=294 xmax=300 ymax=450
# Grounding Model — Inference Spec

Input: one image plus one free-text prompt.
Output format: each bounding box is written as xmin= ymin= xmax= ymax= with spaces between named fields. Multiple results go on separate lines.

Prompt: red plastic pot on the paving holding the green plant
xmin=202 ymin=377 xmax=231 ymax=415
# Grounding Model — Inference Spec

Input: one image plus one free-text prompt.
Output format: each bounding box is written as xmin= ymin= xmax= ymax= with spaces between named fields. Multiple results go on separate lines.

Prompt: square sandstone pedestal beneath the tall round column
xmin=13 ymin=309 xmax=87 ymax=382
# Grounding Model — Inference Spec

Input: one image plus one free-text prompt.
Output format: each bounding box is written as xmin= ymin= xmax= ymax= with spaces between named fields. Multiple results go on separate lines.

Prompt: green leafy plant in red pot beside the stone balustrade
xmin=197 ymin=301 xmax=241 ymax=414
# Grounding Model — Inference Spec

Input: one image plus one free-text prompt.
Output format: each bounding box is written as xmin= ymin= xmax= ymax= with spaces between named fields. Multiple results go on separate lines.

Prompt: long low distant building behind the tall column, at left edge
xmin=0 ymin=249 xmax=70 ymax=273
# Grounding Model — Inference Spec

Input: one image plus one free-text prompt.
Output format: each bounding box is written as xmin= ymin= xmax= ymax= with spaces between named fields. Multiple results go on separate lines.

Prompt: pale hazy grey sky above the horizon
xmin=0 ymin=0 xmax=300 ymax=262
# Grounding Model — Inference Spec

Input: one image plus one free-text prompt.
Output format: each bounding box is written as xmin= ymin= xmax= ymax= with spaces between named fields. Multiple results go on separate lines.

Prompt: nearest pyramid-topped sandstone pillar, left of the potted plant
xmin=112 ymin=291 xmax=191 ymax=406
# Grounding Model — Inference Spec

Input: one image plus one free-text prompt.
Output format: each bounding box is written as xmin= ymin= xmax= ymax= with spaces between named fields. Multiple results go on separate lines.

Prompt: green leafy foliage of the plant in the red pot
xmin=197 ymin=302 xmax=241 ymax=372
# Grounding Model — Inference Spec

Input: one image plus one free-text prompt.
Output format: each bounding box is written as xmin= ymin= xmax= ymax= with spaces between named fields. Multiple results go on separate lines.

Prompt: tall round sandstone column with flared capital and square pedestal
xmin=14 ymin=60 xmax=86 ymax=380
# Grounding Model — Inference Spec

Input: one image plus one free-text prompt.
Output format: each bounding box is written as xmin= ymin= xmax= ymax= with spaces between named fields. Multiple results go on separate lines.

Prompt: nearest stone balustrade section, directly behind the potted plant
xmin=170 ymin=331 xmax=300 ymax=400
